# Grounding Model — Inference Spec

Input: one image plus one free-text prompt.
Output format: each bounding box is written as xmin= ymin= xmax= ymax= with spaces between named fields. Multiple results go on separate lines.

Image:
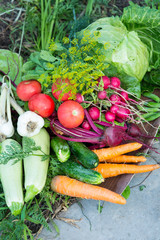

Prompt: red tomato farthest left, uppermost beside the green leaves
xmin=16 ymin=80 xmax=41 ymax=101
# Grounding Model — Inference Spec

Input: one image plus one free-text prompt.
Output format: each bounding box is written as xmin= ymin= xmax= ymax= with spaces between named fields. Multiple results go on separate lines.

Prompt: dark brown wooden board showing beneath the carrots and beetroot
xmin=100 ymin=91 xmax=160 ymax=194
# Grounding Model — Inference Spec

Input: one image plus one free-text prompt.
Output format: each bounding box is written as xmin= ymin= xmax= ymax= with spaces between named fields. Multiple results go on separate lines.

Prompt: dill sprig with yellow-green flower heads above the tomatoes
xmin=39 ymin=33 xmax=108 ymax=99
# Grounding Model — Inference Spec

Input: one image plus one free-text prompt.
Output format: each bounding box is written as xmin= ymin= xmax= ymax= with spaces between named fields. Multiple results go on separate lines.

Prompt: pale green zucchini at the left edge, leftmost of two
xmin=0 ymin=139 xmax=24 ymax=216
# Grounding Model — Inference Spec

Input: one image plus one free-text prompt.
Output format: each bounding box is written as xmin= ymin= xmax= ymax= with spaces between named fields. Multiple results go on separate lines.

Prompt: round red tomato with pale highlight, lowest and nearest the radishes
xmin=57 ymin=100 xmax=84 ymax=128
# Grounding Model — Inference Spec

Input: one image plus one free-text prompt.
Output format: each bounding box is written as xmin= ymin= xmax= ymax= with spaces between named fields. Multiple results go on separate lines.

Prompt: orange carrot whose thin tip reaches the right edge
xmin=94 ymin=163 xmax=160 ymax=178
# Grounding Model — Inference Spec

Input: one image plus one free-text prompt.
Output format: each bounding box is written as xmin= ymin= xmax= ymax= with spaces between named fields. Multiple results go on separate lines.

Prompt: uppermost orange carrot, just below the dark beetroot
xmin=92 ymin=142 xmax=142 ymax=162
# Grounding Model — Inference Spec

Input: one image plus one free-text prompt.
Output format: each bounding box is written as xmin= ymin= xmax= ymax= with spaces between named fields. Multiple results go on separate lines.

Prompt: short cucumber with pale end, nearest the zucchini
xmin=51 ymin=137 xmax=70 ymax=162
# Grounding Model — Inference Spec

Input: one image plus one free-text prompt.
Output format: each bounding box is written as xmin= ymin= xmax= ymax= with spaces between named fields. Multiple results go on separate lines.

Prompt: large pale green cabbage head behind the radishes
xmin=77 ymin=16 xmax=149 ymax=97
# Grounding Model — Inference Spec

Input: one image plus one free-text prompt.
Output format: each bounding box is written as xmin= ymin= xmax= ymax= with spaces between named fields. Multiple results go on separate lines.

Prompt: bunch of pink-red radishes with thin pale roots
xmin=79 ymin=76 xmax=137 ymax=130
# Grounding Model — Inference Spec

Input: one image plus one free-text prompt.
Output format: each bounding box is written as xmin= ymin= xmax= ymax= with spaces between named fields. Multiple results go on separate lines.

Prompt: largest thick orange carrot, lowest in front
xmin=51 ymin=176 xmax=126 ymax=204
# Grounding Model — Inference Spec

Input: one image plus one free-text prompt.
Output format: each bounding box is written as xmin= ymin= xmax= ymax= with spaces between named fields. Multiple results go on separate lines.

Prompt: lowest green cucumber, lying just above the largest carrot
xmin=59 ymin=159 xmax=104 ymax=184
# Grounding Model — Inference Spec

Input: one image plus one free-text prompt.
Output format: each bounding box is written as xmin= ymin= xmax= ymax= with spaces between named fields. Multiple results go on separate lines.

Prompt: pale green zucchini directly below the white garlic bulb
xmin=22 ymin=128 xmax=50 ymax=202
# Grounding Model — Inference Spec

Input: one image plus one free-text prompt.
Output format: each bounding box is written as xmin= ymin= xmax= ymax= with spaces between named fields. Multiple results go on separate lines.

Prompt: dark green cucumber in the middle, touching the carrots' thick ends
xmin=68 ymin=141 xmax=99 ymax=168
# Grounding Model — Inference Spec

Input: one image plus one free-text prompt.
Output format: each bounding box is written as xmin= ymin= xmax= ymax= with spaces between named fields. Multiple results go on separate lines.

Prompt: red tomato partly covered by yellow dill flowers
xmin=52 ymin=78 xmax=71 ymax=101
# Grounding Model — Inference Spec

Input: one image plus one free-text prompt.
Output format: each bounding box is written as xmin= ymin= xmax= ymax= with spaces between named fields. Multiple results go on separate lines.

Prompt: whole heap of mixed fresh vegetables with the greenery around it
xmin=0 ymin=1 xmax=160 ymax=239
